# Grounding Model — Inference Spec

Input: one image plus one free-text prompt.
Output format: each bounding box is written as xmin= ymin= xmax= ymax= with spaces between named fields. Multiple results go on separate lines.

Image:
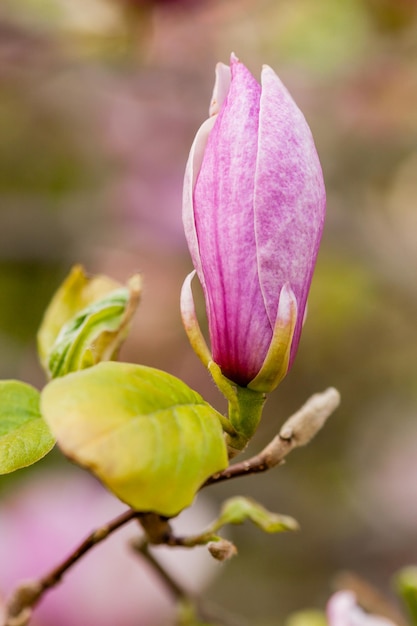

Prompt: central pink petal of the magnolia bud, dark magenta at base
xmin=194 ymin=60 xmax=275 ymax=386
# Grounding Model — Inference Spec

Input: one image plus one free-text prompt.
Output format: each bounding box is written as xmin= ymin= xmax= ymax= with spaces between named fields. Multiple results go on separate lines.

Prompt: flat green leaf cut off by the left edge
xmin=0 ymin=380 xmax=55 ymax=474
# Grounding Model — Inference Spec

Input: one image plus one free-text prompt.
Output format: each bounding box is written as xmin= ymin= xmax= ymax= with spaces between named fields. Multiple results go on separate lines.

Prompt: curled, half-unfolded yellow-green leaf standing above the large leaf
xmin=38 ymin=266 xmax=141 ymax=378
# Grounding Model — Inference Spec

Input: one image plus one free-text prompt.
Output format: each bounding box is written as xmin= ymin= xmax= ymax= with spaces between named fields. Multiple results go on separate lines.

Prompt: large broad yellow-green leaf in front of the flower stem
xmin=41 ymin=362 xmax=227 ymax=517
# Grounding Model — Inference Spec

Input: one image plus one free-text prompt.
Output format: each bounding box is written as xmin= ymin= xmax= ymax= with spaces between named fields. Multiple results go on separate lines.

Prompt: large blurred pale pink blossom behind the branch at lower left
xmin=0 ymin=472 xmax=219 ymax=626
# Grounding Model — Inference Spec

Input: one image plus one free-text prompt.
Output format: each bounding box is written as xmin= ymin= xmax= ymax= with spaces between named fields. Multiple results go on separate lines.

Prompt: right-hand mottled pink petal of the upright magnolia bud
xmin=254 ymin=66 xmax=325 ymax=366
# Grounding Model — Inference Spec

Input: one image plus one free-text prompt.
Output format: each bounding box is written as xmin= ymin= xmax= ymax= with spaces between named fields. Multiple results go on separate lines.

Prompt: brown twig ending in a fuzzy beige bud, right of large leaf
xmin=203 ymin=387 xmax=340 ymax=487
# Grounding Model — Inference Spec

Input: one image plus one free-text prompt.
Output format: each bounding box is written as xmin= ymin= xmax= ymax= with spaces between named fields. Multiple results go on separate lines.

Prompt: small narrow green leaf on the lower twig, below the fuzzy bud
xmin=211 ymin=496 xmax=298 ymax=533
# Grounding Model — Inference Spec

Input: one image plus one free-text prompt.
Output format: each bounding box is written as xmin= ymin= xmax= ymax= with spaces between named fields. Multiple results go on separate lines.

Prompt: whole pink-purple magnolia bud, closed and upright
xmin=181 ymin=55 xmax=325 ymax=392
